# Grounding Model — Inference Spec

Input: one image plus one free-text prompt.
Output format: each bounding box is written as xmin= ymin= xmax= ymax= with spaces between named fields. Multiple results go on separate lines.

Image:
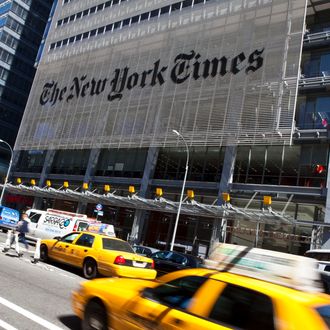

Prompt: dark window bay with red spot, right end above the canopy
xmin=234 ymin=144 xmax=329 ymax=187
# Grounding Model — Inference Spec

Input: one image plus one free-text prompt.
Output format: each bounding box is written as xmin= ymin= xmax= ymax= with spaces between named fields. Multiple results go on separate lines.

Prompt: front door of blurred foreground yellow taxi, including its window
xmin=114 ymin=276 xmax=225 ymax=330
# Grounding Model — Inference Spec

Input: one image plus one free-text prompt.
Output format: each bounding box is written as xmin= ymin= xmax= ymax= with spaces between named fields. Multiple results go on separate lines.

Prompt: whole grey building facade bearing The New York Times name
xmin=7 ymin=0 xmax=330 ymax=255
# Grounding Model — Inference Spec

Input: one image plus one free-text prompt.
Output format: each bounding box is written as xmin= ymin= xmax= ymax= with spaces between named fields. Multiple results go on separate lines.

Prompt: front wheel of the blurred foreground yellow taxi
xmin=82 ymin=301 xmax=108 ymax=330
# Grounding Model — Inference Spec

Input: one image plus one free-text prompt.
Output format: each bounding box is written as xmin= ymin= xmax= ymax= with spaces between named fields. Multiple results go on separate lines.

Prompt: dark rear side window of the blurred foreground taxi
xmin=209 ymin=284 xmax=275 ymax=330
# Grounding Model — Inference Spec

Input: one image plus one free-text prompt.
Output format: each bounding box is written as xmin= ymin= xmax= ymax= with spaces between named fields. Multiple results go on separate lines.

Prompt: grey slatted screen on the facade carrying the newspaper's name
xmin=15 ymin=0 xmax=307 ymax=151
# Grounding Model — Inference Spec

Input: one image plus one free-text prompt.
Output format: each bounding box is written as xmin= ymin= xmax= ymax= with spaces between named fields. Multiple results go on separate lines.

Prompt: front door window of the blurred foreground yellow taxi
xmin=144 ymin=276 xmax=207 ymax=309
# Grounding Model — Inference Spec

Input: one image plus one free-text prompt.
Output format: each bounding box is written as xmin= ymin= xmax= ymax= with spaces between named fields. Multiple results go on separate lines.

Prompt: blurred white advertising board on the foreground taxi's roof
xmin=205 ymin=243 xmax=323 ymax=292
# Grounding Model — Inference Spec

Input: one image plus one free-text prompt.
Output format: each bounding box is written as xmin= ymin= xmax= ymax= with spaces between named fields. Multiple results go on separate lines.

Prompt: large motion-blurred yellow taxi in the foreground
xmin=72 ymin=242 xmax=330 ymax=330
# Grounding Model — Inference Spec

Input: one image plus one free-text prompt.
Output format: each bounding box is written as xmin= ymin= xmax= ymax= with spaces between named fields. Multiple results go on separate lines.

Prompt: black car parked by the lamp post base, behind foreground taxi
xmin=150 ymin=251 xmax=202 ymax=276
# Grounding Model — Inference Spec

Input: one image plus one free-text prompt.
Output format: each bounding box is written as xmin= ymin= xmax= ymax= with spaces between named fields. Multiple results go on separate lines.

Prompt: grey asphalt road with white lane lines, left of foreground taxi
xmin=0 ymin=232 xmax=84 ymax=330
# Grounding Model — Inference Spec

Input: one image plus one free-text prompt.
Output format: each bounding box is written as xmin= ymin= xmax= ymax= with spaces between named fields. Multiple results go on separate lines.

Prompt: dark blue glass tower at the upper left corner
xmin=0 ymin=0 xmax=53 ymax=173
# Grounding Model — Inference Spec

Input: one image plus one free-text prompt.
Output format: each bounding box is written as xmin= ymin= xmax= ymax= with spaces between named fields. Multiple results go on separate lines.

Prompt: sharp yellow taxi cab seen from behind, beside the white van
xmin=40 ymin=232 xmax=157 ymax=280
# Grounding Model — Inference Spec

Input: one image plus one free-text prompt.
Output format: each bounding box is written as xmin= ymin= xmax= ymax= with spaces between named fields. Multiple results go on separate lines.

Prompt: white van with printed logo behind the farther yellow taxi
xmin=26 ymin=209 xmax=92 ymax=240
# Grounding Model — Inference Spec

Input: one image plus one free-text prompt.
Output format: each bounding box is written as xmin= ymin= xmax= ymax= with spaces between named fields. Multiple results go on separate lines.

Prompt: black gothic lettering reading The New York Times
xmin=40 ymin=48 xmax=264 ymax=105
